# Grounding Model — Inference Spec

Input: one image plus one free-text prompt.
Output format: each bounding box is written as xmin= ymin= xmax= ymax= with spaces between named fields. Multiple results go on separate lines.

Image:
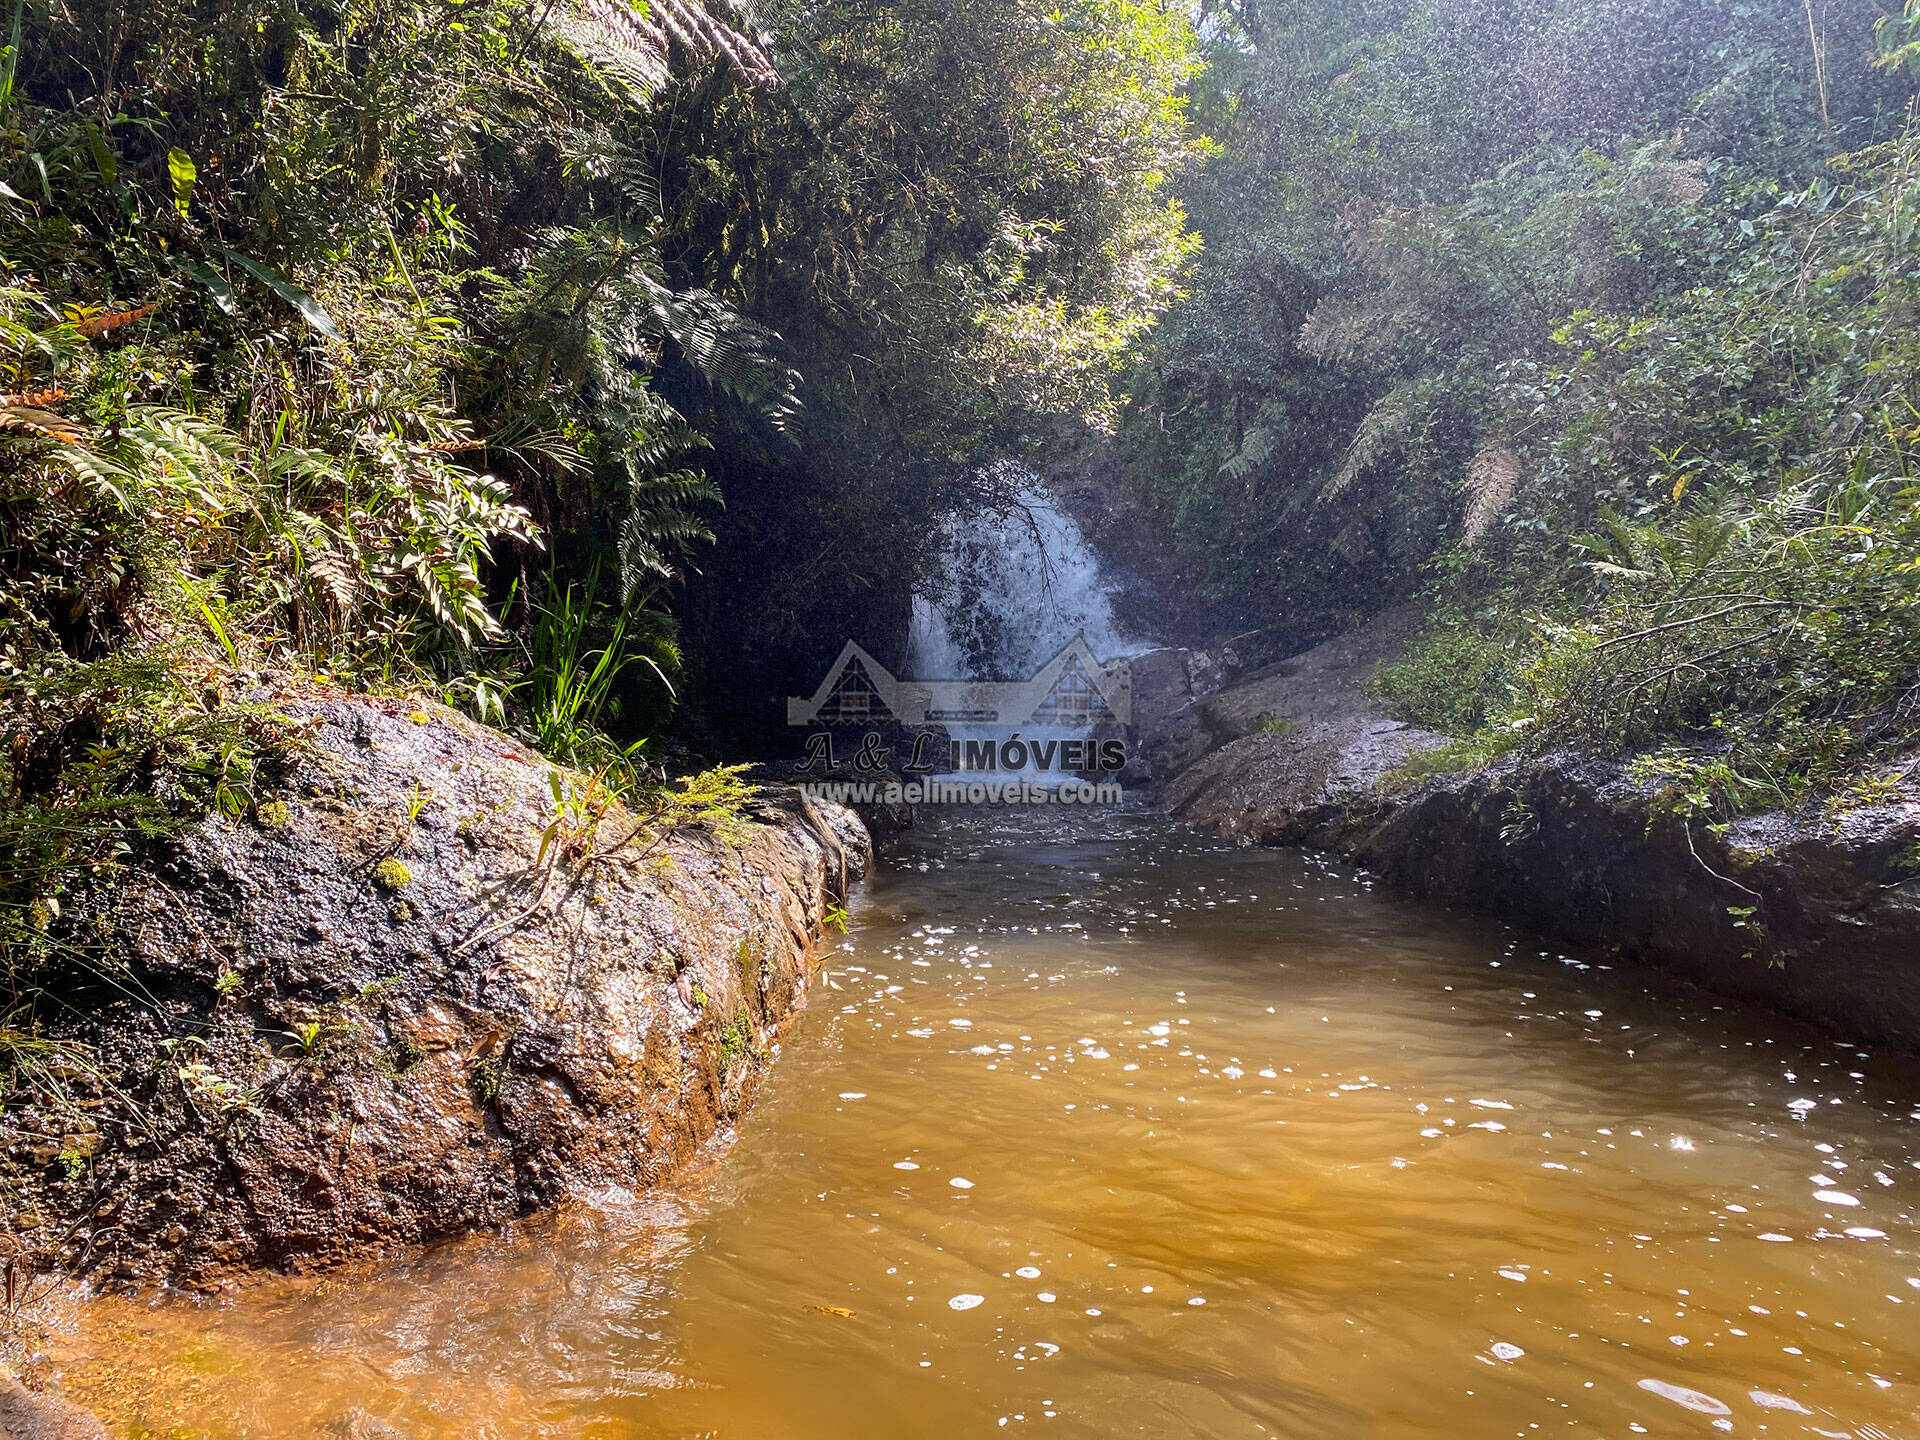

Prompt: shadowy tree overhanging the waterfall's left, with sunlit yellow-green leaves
xmin=648 ymin=0 xmax=1200 ymax=737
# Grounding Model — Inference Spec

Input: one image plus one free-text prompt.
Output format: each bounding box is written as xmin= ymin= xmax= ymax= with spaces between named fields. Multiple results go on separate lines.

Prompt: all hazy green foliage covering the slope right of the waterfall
xmin=1127 ymin=0 xmax=1920 ymax=810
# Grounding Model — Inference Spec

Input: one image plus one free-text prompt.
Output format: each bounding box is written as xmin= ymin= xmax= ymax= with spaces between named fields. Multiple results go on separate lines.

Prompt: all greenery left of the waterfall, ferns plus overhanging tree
xmin=0 ymin=0 xmax=1196 ymax=964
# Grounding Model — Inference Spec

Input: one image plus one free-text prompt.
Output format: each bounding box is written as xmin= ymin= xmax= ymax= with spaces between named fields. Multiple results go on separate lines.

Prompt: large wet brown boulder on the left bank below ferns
xmin=0 ymin=693 xmax=868 ymax=1284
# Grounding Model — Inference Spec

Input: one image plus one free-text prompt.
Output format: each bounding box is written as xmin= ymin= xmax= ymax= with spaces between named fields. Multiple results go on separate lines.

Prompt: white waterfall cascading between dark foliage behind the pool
xmin=906 ymin=478 xmax=1152 ymax=780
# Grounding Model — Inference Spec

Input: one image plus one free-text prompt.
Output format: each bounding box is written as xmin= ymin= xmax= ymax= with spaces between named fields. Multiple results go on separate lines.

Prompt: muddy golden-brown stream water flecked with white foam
xmin=33 ymin=812 xmax=1920 ymax=1440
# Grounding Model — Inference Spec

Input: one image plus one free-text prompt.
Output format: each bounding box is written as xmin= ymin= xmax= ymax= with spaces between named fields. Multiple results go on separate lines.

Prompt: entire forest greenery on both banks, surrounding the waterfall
xmin=0 ymin=0 xmax=1920 ymax=977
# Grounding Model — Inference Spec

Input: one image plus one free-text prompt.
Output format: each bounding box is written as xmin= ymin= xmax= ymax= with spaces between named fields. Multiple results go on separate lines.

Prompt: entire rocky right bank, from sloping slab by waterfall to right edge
xmin=1140 ymin=611 xmax=1920 ymax=1048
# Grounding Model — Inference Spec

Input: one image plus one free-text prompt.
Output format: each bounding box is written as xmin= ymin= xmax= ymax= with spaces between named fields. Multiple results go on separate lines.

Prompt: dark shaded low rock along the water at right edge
xmin=1328 ymin=756 xmax=1920 ymax=1048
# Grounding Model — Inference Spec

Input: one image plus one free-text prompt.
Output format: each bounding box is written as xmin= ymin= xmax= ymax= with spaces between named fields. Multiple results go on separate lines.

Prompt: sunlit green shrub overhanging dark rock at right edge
xmin=1505 ymin=456 xmax=1920 ymax=812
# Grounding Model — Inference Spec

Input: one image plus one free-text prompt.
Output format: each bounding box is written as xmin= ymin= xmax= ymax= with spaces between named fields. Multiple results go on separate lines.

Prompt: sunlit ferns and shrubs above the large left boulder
xmin=0 ymin=0 xmax=810 ymax=985
